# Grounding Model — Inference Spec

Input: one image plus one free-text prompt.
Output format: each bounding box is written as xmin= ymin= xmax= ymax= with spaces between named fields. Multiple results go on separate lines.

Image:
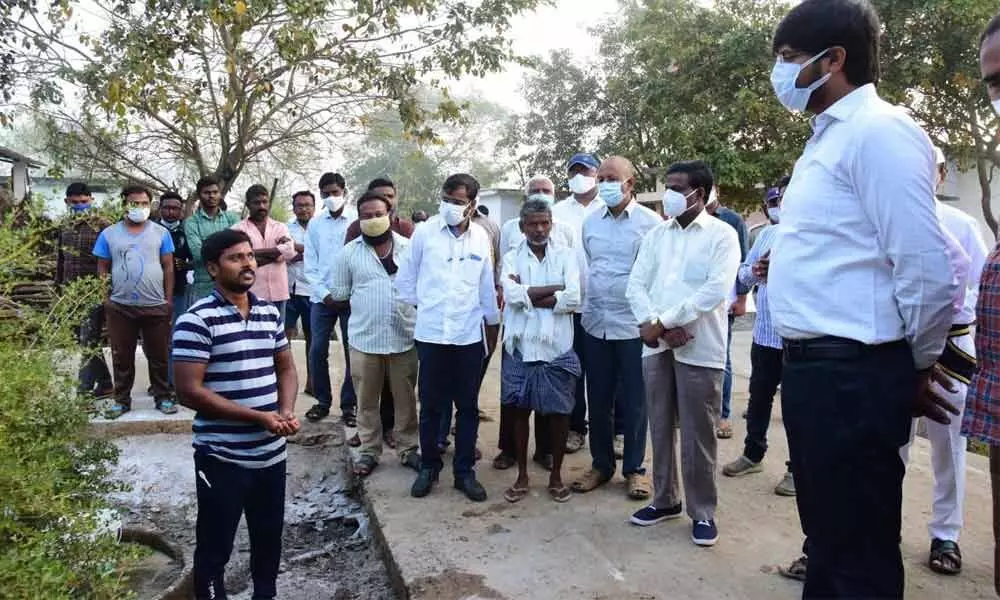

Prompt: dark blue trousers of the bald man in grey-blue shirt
xmin=583 ymin=332 xmax=647 ymax=477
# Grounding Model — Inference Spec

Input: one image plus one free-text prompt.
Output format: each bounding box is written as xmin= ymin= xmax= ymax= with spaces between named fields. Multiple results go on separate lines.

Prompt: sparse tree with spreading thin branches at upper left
xmin=11 ymin=0 xmax=538 ymax=202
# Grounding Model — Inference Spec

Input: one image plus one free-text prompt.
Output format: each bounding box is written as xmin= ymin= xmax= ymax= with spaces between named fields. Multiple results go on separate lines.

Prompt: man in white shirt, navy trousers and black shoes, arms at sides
xmin=396 ymin=174 xmax=500 ymax=502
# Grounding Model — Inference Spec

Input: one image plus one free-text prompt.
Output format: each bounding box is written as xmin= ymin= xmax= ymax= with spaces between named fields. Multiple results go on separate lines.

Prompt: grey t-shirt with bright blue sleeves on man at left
xmin=94 ymin=221 xmax=174 ymax=306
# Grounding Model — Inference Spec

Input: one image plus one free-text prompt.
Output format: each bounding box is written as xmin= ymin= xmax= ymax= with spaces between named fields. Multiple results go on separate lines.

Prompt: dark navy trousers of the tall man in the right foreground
xmin=781 ymin=338 xmax=917 ymax=599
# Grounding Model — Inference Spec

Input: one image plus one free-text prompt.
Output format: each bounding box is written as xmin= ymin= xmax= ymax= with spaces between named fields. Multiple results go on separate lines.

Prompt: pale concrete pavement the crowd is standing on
xmin=97 ymin=331 xmax=994 ymax=600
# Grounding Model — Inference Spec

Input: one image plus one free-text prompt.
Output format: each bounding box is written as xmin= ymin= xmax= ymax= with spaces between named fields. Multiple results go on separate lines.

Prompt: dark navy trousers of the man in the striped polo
xmin=194 ymin=452 xmax=285 ymax=600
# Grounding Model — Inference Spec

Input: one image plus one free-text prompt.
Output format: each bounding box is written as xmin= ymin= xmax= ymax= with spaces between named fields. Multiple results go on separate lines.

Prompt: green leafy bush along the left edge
xmin=0 ymin=205 xmax=130 ymax=600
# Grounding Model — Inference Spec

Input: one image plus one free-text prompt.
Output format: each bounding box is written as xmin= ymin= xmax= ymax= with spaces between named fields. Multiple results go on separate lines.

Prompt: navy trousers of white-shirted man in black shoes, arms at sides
xmin=417 ymin=342 xmax=485 ymax=481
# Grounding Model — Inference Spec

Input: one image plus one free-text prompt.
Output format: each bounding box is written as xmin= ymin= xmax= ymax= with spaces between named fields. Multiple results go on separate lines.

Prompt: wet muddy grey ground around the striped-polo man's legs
xmin=115 ymin=423 xmax=397 ymax=600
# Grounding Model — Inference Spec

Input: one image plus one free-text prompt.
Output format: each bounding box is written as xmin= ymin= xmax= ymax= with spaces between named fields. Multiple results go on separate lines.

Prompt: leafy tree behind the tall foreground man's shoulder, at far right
xmin=873 ymin=0 xmax=1000 ymax=236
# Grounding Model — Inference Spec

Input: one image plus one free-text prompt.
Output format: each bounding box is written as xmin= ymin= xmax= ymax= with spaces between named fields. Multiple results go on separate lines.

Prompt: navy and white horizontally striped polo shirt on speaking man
xmin=173 ymin=290 xmax=288 ymax=469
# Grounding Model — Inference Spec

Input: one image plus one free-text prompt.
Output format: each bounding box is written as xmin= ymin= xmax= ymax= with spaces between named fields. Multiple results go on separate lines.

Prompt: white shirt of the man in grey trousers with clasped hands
xmin=626 ymin=210 xmax=740 ymax=369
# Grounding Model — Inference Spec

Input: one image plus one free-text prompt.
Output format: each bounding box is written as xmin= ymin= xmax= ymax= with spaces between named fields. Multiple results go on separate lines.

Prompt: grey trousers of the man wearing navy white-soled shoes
xmin=642 ymin=350 xmax=725 ymax=521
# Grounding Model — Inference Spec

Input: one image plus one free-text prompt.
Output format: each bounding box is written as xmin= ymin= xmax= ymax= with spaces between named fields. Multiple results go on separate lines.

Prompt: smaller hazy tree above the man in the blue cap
xmin=498 ymin=50 xmax=604 ymax=185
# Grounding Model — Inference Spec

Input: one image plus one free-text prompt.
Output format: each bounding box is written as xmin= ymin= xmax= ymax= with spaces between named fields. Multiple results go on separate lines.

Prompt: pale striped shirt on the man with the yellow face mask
xmin=330 ymin=232 xmax=417 ymax=354
